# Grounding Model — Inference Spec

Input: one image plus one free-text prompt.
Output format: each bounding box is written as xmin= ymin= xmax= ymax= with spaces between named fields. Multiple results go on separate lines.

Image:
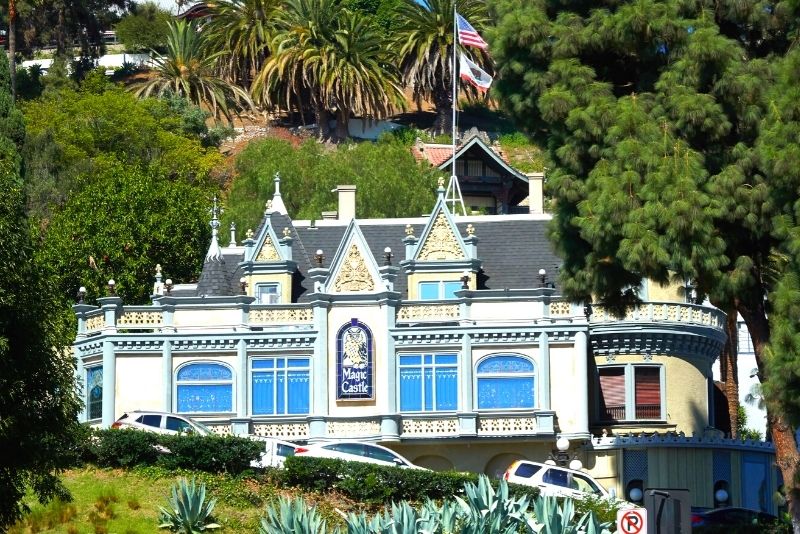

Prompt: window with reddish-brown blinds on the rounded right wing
xmin=597 ymin=364 xmax=664 ymax=421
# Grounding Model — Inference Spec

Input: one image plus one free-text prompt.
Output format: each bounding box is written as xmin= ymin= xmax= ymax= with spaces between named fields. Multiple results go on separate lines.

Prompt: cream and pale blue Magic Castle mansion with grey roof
xmin=74 ymin=150 xmax=778 ymax=512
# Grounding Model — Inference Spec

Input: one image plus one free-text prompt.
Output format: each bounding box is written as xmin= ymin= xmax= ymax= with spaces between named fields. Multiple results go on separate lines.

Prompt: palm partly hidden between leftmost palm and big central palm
xmin=203 ymin=0 xmax=282 ymax=86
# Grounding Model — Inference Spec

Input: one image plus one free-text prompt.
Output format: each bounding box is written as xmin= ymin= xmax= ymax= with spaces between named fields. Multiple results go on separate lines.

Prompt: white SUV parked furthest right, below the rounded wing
xmin=503 ymin=460 xmax=613 ymax=499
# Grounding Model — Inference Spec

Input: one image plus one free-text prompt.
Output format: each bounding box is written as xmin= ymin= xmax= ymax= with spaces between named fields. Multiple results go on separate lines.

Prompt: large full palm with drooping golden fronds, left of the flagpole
xmin=252 ymin=0 xmax=404 ymax=139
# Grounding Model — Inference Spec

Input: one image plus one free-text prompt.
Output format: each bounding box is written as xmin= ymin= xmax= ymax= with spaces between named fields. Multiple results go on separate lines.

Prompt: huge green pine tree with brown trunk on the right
xmin=491 ymin=0 xmax=800 ymax=532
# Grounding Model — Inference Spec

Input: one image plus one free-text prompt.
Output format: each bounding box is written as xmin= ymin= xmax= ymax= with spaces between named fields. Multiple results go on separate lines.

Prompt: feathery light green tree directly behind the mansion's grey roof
xmin=222 ymin=139 xmax=441 ymax=235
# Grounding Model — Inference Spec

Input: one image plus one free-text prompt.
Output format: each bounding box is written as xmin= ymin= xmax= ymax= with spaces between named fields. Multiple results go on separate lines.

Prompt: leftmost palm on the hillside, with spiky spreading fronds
xmin=131 ymin=20 xmax=253 ymax=121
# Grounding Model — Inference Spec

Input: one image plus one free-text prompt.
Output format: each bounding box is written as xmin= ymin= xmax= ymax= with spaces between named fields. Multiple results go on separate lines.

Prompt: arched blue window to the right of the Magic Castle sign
xmin=477 ymin=354 xmax=536 ymax=410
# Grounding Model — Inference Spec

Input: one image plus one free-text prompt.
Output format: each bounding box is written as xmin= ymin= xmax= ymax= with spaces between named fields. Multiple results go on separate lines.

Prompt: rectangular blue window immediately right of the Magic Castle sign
xmin=399 ymin=354 xmax=458 ymax=412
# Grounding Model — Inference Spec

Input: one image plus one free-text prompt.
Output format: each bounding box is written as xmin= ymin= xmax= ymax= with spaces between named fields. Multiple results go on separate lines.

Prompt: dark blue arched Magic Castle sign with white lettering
xmin=336 ymin=319 xmax=375 ymax=400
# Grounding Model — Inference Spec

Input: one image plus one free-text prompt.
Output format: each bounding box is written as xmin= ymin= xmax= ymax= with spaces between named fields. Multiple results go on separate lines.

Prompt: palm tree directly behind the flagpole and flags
xmin=395 ymin=0 xmax=491 ymax=132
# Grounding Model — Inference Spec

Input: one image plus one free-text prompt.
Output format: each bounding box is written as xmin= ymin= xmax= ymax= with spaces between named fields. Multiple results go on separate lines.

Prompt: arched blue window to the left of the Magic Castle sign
xmin=176 ymin=362 xmax=233 ymax=413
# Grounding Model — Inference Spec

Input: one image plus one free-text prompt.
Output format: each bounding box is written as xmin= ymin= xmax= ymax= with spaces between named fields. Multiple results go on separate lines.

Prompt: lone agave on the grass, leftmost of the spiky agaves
xmin=158 ymin=478 xmax=219 ymax=534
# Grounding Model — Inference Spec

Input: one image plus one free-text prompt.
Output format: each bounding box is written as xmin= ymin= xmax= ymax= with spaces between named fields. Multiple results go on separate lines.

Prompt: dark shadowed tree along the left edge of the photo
xmin=0 ymin=47 xmax=80 ymax=531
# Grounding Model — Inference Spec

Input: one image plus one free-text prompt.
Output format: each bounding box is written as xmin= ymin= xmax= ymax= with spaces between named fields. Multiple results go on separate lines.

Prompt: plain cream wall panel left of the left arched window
xmin=114 ymin=354 xmax=162 ymax=419
